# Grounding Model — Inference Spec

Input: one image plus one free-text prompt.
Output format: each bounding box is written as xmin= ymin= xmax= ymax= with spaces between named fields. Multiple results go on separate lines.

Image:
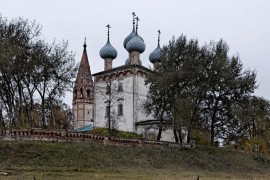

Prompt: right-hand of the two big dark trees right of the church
xmin=202 ymin=40 xmax=257 ymax=145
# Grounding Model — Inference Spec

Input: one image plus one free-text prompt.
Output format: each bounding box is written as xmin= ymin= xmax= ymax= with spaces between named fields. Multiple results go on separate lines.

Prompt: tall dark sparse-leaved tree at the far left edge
xmin=0 ymin=16 xmax=41 ymax=125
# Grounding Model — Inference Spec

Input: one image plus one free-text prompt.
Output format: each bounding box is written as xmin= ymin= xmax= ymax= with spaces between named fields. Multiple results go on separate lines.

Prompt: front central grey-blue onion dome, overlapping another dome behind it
xmin=126 ymin=34 xmax=145 ymax=53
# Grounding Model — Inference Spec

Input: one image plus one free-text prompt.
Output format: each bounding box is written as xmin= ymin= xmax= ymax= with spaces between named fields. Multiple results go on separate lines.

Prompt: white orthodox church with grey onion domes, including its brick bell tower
xmin=72 ymin=13 xmax=186 ymax=141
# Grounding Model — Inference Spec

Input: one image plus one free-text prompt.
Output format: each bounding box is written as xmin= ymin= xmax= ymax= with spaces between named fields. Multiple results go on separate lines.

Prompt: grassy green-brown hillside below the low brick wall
xmin=0 ymin=141 xmax=270 ymax=179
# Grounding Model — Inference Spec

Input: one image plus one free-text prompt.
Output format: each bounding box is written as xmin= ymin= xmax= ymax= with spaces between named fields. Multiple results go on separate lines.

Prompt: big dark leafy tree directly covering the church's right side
xmin=145 ymin=35 xmax=205 ymax=142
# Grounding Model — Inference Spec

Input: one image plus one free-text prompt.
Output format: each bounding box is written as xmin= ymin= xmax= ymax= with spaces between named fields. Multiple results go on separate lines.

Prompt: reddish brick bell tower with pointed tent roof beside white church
xmin=72 ymin=40 xmax=94 ymax=129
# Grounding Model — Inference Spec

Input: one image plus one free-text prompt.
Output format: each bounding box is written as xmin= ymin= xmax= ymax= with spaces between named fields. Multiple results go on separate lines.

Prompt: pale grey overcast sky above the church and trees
xmin=0 ymin=0 xmax=270 ymax=105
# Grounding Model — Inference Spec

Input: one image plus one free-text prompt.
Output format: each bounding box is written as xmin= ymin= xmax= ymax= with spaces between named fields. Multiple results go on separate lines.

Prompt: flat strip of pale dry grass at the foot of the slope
xmin=0 ymin=169 xmax=270 ymax=180
